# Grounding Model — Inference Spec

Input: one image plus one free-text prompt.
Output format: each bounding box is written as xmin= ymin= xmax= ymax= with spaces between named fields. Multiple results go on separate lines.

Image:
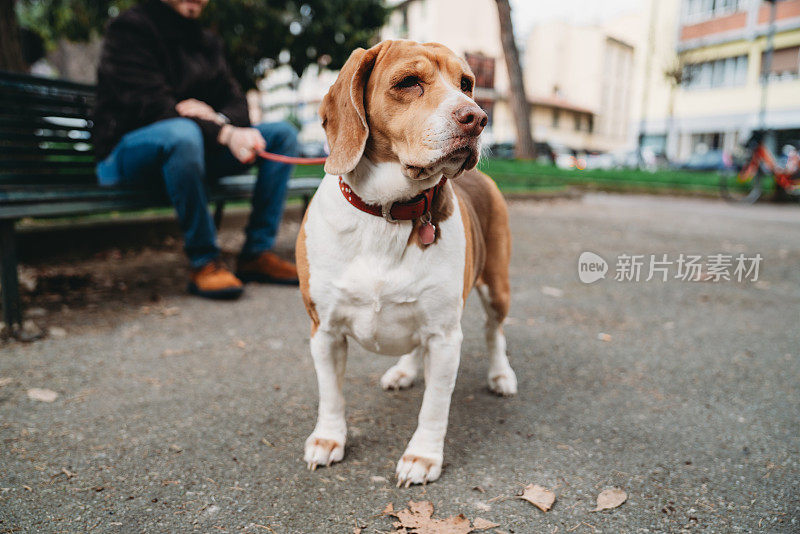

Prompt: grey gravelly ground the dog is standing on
xmin=0 ymin=195 xmax=800 ymax=533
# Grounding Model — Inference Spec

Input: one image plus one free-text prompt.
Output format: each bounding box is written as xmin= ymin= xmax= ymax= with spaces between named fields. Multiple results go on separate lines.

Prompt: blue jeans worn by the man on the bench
xmin=97 ymin=118 xmax=297 ymax=268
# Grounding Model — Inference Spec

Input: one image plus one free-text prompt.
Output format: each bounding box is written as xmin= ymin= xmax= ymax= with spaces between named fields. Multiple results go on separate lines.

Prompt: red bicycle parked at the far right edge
xmin=720 ymin=135 xmax=800 ymax=204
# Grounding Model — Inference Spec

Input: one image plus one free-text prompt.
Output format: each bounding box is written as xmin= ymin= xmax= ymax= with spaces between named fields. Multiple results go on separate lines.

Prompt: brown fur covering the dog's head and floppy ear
xmin=319 ymin=40 xmax=475 ymax=175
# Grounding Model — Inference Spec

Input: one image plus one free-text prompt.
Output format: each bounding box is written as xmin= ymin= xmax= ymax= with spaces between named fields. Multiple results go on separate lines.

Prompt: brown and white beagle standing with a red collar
xmin=296 ymin=41 xmax=517 ymax=486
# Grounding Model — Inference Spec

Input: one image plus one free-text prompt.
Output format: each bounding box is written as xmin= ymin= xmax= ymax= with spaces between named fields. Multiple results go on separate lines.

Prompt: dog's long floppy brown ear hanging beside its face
xmin=319 ymin=43 xmax=383 ymax=176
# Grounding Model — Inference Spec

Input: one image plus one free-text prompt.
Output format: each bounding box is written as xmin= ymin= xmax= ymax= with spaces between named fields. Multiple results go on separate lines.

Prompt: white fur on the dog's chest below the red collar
xmin=306 ymin=175 xmax=466 ymax=355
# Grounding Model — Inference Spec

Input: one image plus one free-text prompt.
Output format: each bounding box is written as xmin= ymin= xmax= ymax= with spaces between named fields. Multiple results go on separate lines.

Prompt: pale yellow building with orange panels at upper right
xmin=643 ymin=0 xmax=800 ymax=160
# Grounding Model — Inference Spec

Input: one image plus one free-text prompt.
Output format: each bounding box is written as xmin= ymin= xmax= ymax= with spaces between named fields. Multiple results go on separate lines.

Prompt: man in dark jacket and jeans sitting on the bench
xmin=94 ymin=0 xmax=297 ymax=298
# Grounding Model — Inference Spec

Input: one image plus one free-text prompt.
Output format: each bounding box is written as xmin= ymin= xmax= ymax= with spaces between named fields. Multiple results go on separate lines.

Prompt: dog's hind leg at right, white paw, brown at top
xmin=476 ymin=284 xmax=517 ymax=396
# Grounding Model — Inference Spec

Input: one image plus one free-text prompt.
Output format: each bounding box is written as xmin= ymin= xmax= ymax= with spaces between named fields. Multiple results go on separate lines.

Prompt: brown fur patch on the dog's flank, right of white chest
xmin=454 ymin=170 xmax=511 ymax=322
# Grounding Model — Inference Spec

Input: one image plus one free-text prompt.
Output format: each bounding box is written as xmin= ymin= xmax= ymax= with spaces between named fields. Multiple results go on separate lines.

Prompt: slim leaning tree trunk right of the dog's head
xmin=496 ymin=0 xmax=536 ymax=159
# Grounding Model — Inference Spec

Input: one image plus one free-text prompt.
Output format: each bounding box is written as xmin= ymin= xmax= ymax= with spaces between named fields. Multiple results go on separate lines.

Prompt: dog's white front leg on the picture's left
xmin=304 ymin=330 xmax=347 ymax=470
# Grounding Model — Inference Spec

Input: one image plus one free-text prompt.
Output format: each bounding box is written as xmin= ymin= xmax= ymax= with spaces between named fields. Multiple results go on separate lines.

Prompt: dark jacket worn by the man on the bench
xmin=94 ymin=0 xmax=250 ymax=159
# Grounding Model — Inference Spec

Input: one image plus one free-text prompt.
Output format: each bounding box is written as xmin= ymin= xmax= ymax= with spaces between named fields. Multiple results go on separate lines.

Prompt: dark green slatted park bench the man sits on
xmin=0 ymin=71 xmax=320 ymax=342
